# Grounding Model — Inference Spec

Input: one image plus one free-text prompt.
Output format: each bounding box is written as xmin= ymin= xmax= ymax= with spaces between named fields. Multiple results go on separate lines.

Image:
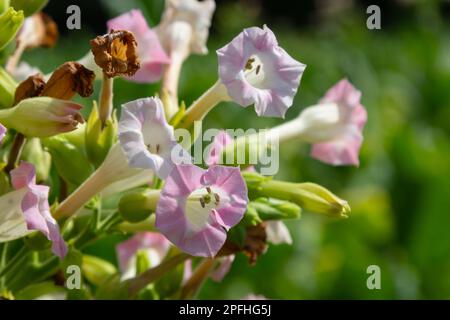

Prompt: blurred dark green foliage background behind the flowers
xmin=24 ymin=0 xmax=450 ymax=299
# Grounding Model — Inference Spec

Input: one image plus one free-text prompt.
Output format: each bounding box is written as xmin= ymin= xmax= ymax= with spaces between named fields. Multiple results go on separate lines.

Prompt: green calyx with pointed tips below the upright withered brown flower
xmin=86 ymin=101 xmax=117 ymax=167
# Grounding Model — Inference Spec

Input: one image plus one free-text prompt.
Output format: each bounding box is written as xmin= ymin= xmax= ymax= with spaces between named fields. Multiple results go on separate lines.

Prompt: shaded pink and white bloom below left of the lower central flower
xmin=116 ymin=232 xmax=170 ymax=280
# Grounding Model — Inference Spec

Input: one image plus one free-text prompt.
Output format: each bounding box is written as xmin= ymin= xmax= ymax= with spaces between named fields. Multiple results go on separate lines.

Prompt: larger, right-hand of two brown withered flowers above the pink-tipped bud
xmin=42 ymin=61 xmax=95 ymax=100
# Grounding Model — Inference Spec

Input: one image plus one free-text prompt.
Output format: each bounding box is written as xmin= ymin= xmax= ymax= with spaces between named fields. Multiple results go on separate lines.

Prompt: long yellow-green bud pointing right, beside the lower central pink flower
xmin=242 ymin=172 xmax=350 ymax=218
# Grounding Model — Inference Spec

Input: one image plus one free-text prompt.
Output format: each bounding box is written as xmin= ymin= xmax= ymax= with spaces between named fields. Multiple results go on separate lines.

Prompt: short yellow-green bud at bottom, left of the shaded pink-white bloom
xmin=82 ymin=255 xmax=117 ymax=286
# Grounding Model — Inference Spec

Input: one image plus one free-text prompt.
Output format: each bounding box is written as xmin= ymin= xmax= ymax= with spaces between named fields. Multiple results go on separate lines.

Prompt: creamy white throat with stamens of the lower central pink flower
xmin=185 ymin=187 xmax=229 ymax=231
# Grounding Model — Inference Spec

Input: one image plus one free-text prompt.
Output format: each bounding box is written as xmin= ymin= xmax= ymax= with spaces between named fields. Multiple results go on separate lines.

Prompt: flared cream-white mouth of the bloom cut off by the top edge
xmin=157 ymin=0 xmax=216 ymax=58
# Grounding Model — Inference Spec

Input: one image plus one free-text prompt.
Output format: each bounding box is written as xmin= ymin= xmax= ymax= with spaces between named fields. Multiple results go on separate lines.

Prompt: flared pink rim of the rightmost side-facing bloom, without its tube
xmin=305 ymin=79 xmax=367 ymax=166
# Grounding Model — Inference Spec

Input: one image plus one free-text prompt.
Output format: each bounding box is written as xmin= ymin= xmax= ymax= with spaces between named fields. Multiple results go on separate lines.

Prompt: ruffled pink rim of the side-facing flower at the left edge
xmin=11 ymin=162 xmax=67 ymax=259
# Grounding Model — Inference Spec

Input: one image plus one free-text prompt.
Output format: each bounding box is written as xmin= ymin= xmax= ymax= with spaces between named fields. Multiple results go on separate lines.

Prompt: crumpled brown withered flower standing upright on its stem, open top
xmin=91 ymin=30 xmax=140 ymax=78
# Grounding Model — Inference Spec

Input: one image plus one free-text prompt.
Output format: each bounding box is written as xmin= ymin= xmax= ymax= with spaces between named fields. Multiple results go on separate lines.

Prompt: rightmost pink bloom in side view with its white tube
xmin=268 ymin=79 xmax=367 ymax=166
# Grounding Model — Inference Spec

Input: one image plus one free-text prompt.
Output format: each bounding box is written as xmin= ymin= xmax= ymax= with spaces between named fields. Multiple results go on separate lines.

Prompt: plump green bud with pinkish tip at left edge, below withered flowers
xmin=0 ymin=97 xmax=84 ymax=138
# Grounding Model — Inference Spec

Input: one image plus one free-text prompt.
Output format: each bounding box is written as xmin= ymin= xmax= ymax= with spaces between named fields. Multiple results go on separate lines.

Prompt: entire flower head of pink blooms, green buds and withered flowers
xmin=0 ymin=0 xmax=367 ymax=299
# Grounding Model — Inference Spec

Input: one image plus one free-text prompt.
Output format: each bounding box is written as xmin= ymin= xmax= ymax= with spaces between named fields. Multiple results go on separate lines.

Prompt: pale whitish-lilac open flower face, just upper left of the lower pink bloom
xmin=119 ymin=98 xmax=190 ymax=179
